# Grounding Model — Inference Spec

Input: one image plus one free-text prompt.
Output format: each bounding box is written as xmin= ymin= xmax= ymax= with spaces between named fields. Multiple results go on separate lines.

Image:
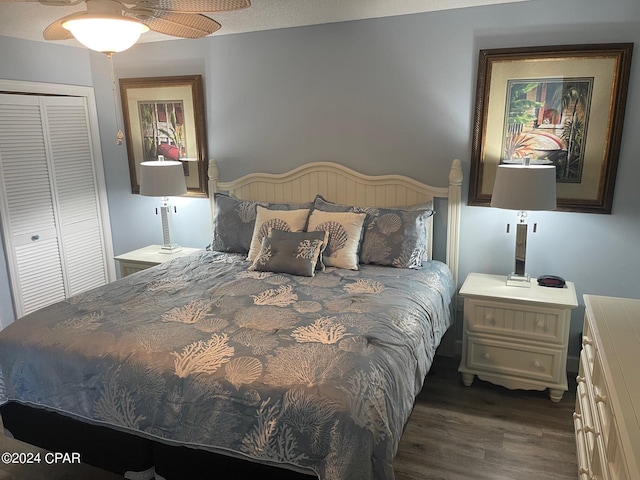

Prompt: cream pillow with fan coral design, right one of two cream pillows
xmin=307 ymin=210 xmax=366 ymax=270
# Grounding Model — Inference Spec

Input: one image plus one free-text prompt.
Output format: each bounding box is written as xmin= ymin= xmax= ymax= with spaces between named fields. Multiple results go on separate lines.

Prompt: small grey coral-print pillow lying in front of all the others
xmin=249 ymin=230 xmax=325 ymax=277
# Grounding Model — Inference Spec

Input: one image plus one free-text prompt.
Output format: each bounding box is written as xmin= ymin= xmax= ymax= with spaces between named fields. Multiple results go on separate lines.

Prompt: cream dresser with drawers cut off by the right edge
xmin=574 ymin=295 xmax=640 ymax=480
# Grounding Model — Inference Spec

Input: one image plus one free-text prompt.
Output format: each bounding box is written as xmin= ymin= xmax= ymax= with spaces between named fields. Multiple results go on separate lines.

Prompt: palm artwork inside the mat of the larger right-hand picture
xmin=500 ymin=77 xmax=593 ymax=183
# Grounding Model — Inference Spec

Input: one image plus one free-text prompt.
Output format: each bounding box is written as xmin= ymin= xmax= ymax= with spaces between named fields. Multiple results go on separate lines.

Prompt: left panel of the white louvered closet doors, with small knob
xmin=0 ymin=95 xmax=65 ymax=317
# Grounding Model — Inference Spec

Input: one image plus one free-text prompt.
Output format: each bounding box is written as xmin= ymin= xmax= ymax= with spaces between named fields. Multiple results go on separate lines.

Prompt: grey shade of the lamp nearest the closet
xmin=140 ymin=160 xmax=187 ymax=197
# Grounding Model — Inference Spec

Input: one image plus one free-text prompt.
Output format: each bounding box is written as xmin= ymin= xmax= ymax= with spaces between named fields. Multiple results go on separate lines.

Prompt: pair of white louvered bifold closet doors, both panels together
xmin=0 ymin=86 xmax=114 ymax=318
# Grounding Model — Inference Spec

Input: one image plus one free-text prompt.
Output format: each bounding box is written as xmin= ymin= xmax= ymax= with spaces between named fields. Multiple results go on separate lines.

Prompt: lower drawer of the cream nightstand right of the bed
xmin=467 ymin=335 xmax=564 ymax=382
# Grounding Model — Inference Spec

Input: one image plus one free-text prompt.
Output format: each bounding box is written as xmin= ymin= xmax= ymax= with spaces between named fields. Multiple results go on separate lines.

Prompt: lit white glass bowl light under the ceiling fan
xmin=62 ymin=17 xmax=149 ymax=53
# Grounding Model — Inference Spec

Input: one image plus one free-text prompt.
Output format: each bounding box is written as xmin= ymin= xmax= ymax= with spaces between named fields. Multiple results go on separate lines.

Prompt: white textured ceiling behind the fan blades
xmin=0 ymin=0 xmax=527 ymax=46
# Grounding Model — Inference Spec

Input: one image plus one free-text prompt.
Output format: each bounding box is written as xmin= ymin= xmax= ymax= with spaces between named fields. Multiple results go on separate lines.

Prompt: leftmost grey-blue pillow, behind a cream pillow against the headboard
xmin=207 ymin=193 xmax=311 ymax=253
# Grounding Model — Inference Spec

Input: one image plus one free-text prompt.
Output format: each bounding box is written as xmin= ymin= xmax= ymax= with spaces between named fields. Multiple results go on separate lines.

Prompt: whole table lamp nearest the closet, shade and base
xmin=140 ymin=157 xmax=187 ymax=253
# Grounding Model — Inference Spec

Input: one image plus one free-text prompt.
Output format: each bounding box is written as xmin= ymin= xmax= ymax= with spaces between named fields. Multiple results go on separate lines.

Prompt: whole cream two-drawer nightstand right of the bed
xmin=458 ymin=273 xmax=578 ymax=402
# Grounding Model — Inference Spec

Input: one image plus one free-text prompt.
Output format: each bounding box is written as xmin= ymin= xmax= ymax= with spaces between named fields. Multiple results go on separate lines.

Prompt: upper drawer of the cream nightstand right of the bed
xmin=465 ymin=299 xmax=567 ymax=344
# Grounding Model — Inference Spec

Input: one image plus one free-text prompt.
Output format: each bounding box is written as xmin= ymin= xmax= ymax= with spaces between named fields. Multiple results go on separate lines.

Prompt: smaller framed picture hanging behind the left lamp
xmin=120 ymin=75 xmax=207 ymax=197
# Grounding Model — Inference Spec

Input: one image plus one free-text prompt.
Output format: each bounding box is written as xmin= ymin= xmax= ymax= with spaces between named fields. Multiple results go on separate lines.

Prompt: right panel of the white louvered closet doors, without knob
xmin=42 ymin=97 xmax=107 ymax=296
